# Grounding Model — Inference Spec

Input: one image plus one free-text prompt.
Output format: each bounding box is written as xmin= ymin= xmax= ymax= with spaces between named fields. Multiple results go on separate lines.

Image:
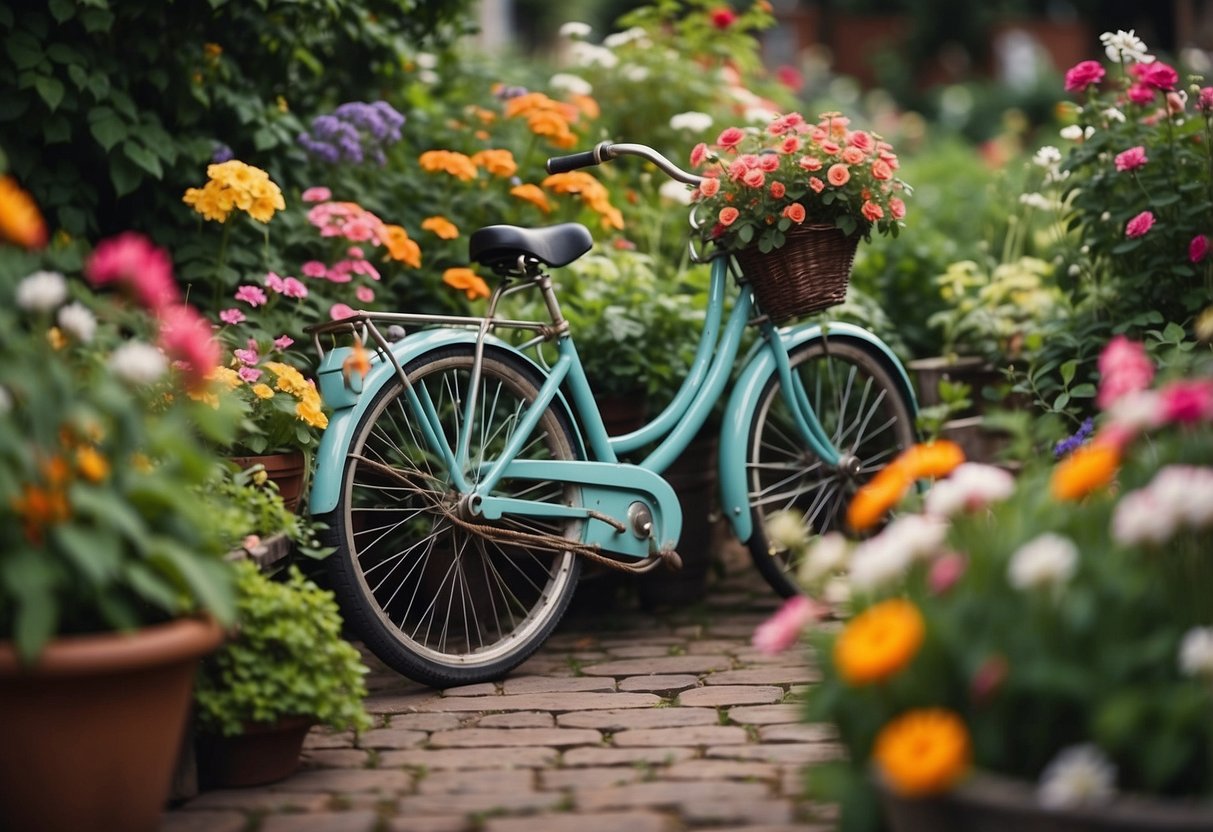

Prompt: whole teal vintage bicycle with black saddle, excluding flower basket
xmin=311 ymin=142 xmax=917 ymax=688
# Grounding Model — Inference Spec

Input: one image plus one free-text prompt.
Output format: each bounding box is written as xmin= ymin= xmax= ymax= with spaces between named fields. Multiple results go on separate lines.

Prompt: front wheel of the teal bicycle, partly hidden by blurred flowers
xmin=746 ymin=336 xmax=916 ymax=597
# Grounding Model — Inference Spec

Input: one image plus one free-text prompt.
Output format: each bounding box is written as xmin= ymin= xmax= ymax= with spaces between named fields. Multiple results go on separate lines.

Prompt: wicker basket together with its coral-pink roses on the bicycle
xmin=690 ymin=113 xmax=910 ymax=321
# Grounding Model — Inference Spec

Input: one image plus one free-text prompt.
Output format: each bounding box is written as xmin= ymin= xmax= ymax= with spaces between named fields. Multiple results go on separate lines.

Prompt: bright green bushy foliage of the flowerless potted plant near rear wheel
xmin=194 ymin=560 xmax=371 ymax=736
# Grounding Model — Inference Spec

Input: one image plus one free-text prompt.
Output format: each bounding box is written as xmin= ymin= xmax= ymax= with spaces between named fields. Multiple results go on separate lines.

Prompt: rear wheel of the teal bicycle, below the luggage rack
xmin=321 ymin=344 xmax=581 ymax=688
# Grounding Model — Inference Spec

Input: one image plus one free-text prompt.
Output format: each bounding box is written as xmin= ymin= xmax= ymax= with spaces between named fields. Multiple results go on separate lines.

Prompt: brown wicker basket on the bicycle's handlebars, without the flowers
xmin=734 ymin=224 xmax=859 ymax=324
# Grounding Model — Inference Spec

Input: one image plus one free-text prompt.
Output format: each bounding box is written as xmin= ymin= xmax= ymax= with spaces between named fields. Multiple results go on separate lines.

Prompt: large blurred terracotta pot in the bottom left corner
xmin=0 ymin=619 xmax=223 ymax=832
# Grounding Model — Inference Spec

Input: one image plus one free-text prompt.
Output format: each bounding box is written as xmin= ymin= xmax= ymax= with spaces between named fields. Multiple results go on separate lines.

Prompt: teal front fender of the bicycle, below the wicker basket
xmin=719 ymin=321 xmax=918 ymax=543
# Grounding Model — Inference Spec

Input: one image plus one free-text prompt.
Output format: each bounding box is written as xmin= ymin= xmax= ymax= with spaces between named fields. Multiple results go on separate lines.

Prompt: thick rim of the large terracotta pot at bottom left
xmin=0 ymin=616 xmax=224 ymax=678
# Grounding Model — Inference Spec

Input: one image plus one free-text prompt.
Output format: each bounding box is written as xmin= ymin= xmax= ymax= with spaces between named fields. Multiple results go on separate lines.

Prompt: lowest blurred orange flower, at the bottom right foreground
xmin=872 ymin=708 xmax=970 ymax=797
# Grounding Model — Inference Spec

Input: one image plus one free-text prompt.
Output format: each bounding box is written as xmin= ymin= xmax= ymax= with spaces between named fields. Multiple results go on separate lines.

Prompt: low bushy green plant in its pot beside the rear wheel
xmin=194 ymin=560 xmax=370 ymax=788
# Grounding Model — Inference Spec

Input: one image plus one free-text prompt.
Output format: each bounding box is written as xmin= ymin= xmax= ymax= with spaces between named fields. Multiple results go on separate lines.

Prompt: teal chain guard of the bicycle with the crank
xmin=471 ymin=460 xmax=682 ymax=559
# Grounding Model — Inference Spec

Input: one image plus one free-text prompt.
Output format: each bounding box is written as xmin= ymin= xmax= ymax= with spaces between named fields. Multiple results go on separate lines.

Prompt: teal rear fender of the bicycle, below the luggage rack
xmin=308 ymin=329 xmax=562 ymax=514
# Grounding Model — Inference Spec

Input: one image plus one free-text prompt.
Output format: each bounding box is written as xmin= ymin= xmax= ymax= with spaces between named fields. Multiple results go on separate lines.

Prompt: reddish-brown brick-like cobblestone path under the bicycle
xmin=163 ymin=555 xmax=837 ymax=832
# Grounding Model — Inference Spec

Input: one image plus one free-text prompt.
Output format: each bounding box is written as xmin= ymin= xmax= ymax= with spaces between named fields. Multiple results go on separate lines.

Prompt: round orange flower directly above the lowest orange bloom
xmin=833 ymin=598 xmax=926 ymax=685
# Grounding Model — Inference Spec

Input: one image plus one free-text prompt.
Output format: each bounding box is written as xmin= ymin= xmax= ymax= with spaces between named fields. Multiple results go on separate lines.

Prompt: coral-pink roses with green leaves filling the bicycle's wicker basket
xmin=690 ymin=113 xmax=910 ymax=252
